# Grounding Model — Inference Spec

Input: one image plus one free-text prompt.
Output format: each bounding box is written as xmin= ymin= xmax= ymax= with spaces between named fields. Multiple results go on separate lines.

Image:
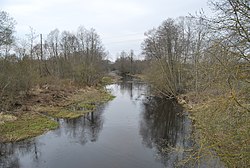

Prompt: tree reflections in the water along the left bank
xmin=0 ymin=105 xmax=105 ymax=168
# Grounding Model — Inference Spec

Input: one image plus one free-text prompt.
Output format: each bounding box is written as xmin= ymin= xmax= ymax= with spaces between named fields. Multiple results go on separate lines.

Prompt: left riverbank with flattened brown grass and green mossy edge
xmin=0 ymin=85 xmax=114 ymax=142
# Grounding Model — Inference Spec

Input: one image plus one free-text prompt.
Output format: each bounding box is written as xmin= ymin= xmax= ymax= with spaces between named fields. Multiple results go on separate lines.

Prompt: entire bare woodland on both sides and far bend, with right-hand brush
xmin=0 ymin=0 xmax=250 ymax=167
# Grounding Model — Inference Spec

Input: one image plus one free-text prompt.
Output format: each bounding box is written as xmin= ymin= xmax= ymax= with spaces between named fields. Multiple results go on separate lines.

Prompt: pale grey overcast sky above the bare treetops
xmin=0 ymin=0 xmax=210 ymax=60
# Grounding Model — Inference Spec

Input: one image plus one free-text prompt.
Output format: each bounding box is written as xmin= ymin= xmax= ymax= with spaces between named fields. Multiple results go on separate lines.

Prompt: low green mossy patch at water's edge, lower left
xmin=0 ymin=113 xmax=58 ymax=142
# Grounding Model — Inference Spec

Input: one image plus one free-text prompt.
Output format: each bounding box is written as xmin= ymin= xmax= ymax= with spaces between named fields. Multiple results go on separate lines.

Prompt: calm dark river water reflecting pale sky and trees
xmin=0 ymin=81 xmax=191 ymax=168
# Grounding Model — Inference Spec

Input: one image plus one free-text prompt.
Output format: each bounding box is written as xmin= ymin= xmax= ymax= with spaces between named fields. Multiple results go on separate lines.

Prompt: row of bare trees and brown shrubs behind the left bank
xmin=0 ymin=11 xmax=109 ymax=110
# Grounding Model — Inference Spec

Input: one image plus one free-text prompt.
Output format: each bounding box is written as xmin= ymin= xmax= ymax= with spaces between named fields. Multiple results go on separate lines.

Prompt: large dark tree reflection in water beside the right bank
xmin=140 ymin=98 xmax=191 ymax=167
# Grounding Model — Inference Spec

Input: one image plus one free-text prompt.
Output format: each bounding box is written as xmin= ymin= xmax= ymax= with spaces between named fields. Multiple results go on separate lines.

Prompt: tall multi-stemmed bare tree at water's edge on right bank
xmin=143 ymin=19 xmax=183 ymax=96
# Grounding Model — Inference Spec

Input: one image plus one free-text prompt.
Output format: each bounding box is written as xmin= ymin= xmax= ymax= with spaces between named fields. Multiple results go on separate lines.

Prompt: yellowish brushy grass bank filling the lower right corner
xmin=182 ymin=94 xmax=250 ymax=167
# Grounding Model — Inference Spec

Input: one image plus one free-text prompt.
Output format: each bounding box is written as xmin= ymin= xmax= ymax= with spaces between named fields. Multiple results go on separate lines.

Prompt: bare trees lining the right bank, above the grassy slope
xmin=142 ymin=0 xmax=250 ymax=97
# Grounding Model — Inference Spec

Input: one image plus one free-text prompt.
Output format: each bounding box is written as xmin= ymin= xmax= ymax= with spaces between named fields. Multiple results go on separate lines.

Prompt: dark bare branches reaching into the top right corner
xmin=211 ymin=0 xmax=250 ymax=62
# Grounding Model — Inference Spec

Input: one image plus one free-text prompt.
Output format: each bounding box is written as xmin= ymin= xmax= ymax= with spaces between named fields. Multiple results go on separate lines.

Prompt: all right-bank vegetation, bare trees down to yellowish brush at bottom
xmin=142 ymin=0 xmax=250 ymax=167
